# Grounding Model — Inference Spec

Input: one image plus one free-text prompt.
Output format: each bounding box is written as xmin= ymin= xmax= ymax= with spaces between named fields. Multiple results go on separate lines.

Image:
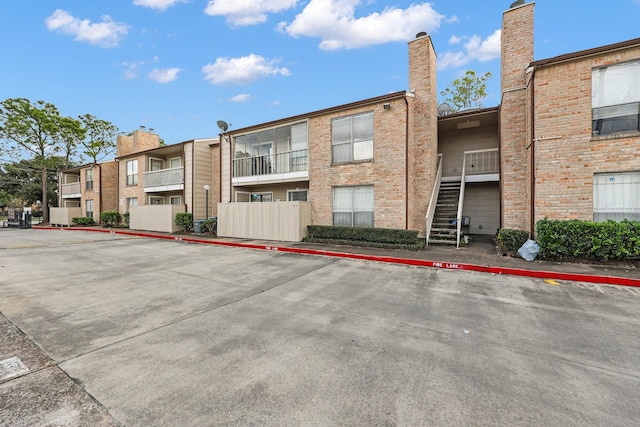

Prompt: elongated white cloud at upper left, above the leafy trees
xmin=45 ymin=9 xmax=129 ymax=47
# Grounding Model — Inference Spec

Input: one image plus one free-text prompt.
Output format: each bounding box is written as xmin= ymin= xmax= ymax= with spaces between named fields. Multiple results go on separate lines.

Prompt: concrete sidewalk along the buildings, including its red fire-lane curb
xmin=33 ymin=225 xmax=640 ymax=287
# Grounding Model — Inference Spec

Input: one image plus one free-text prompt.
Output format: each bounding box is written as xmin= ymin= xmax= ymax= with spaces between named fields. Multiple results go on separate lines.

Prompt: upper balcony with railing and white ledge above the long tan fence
xmin=233 ymin=149 xmax=309 ymax=183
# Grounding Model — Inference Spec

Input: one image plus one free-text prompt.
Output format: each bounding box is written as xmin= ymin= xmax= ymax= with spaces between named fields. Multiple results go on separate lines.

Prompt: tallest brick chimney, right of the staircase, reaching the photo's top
xmin=500 ymin=3 xmax=534 ymax=230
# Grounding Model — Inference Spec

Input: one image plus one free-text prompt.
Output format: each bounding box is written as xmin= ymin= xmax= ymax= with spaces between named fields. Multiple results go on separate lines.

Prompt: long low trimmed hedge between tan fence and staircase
xmin=305 ymin=225 xmax=424 ymax=250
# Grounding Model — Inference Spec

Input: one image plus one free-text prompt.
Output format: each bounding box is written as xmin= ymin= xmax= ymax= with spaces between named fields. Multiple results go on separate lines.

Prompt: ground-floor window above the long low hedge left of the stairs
xmin=333 ymin=185 xmax=373 ymax=227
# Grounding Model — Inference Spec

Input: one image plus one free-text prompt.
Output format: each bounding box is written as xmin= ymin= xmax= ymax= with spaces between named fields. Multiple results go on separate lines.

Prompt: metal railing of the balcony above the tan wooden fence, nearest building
xmin=233 ymin=149 xmax=308 ymax=177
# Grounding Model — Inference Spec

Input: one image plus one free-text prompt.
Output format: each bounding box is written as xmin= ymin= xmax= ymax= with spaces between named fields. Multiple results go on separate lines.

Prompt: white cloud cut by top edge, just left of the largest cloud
xmin=204 ymin=0 xmax=298 ymax=27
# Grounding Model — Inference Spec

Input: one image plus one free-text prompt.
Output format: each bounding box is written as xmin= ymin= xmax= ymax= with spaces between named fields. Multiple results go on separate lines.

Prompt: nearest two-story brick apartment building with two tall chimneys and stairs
xmin=217 ymin=2 xmax=640 ymax=243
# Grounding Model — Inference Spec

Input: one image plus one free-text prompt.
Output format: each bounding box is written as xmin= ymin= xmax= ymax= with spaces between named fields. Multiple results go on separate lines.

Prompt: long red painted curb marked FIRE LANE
xmin=33 ymin=226 xmax=640 ymax=287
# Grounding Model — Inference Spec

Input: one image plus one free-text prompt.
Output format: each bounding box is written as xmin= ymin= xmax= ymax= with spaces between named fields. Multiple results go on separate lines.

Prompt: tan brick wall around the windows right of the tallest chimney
xmin=534 ymin=48 xmax=640 ymax=221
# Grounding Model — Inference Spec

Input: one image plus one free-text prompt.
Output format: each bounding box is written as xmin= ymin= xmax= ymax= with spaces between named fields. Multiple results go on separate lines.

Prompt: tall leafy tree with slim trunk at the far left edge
xmin=0 ymin=98 xmax=82 ymax=222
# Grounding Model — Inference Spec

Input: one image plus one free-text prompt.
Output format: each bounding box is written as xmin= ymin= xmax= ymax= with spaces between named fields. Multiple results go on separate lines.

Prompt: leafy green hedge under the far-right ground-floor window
xmin=536 ymin=219 xmax=640 ymax=261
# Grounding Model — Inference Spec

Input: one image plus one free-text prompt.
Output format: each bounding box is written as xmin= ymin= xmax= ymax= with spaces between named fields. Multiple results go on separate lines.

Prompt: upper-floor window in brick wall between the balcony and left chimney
xmin=331 ymin=113 xmax=373 ymax=163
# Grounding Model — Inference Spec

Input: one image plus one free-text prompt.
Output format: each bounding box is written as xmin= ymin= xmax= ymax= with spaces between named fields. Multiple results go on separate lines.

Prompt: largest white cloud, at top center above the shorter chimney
xmin=278 ymin=0 xmax=444 ymax=50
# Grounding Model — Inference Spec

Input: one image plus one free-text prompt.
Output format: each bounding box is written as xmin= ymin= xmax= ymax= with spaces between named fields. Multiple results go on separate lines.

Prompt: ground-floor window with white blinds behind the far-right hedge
xmin=593 ymin=172 xmax=640 ymax=221
